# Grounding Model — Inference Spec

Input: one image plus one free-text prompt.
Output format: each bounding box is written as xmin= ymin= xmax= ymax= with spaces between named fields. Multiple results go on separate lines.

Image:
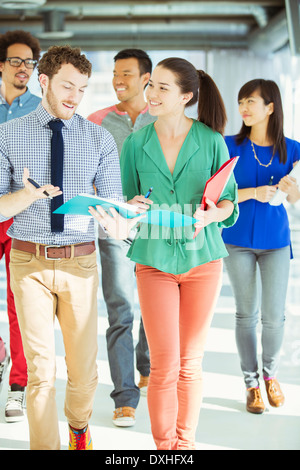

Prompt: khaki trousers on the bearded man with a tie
xmin=10 ymin=249 xmax=98 ymax=450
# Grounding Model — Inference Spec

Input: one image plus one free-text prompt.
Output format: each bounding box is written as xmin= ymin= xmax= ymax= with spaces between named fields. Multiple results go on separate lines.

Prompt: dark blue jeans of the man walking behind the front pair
xmin=98 ymin=238 xmax=150 ymax=408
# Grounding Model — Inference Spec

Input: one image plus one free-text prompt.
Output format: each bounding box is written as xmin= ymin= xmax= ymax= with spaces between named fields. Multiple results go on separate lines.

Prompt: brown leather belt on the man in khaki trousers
xmin=12 ymin=238 xmax=96 ymax=260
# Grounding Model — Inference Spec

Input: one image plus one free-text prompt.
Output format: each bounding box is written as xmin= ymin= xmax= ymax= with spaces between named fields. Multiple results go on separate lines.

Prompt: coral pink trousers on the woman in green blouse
xmin=136 ymin=260 xmax=222 ymax=450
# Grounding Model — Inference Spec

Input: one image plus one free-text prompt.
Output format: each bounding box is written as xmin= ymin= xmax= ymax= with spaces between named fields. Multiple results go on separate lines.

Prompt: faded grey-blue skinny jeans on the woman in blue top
xmin=224 ymin=245 xmax=290 ymax=388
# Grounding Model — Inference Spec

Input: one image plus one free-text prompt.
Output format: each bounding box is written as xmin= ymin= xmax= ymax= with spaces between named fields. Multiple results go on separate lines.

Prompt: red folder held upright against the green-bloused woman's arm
xmin=193 ymin=157 xmax=239 ymax=238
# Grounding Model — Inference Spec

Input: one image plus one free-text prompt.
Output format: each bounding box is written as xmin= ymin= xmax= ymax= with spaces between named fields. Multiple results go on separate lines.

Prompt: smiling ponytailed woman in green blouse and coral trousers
xmin=91 ymin=58 xmax=237 ymax=449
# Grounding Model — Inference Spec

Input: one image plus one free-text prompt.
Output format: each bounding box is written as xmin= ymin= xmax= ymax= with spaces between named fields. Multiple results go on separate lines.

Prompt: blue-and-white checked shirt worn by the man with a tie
xmin=0 ymin=104 xmax=123 ymax=245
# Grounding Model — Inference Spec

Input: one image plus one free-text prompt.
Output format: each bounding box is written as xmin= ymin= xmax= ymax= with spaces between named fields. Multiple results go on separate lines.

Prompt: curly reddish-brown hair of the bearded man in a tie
xmin=38 ymin=45 xmax=92 ymax=79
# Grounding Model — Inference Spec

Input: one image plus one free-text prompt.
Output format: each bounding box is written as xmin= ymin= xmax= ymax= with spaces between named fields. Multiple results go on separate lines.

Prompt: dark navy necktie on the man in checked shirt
xmin=48 ymin=119 xmax=64 ymax=232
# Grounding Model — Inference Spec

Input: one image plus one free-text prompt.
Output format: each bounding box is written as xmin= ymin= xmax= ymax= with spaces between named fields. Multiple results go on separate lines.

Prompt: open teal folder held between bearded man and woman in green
xmin=54 ymin=194 xmax=197 ymax=228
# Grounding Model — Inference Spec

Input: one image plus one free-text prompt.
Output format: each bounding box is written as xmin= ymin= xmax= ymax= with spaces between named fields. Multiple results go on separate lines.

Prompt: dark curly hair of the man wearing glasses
xmin=0 ymin=30 xmax=41 ymax=76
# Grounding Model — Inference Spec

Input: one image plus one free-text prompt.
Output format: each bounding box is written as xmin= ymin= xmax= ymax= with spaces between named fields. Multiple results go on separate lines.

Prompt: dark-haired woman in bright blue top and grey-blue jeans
xmin=222 ymin=79 xmax=300 ymax=414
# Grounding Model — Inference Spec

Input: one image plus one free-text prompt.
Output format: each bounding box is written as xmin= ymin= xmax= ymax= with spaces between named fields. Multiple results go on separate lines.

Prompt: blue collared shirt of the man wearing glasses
xmin=0 ymin=86 xmax=41 ymax=124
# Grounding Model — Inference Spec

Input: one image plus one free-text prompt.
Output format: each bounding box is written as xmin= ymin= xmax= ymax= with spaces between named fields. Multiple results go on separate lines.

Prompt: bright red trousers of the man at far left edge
xmin=0 ymin=219 xmax=27 ymax=387
